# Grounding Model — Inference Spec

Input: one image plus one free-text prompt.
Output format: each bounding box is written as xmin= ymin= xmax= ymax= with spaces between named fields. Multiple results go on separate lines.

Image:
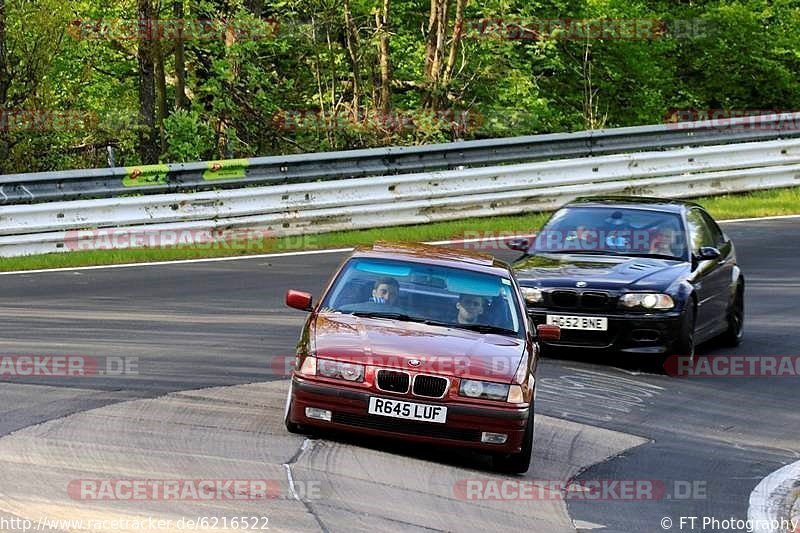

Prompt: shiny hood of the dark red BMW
xmin=314 ymin=314 xmax=525 ymax=383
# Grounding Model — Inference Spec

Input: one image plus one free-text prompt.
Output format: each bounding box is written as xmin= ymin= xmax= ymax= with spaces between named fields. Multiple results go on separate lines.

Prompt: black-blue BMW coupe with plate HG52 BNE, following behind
xmin=509 ymin=196 xmax=745 ymax=360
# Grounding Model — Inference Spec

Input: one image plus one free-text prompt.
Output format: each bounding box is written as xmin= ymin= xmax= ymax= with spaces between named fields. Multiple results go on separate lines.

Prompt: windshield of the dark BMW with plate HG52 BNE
xmin=532 ymin=207 xmax=686 ymax=259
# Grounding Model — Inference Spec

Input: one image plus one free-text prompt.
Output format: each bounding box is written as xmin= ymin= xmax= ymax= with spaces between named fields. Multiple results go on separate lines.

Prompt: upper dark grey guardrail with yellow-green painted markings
xmin=0 ymin=113 xmax=800 ymax=206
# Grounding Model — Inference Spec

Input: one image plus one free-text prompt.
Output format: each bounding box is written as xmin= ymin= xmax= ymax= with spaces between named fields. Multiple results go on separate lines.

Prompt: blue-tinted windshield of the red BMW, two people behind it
xmin=321 ymin=258 xmax=523 ymax=336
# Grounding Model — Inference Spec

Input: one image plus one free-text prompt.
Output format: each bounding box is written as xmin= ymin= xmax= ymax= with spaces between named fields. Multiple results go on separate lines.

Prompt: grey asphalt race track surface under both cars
xmin=0 ymin=219 xmax=800 ymax=533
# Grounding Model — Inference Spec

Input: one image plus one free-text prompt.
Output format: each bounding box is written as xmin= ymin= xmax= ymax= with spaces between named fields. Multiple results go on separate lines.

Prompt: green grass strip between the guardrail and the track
xmin=0 ymin=187 xmax=800 ymax=272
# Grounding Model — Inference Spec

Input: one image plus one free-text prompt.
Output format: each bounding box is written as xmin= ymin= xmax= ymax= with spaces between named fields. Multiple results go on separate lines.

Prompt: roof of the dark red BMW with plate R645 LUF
xmin=353 ymin=241 xmax=510 ymax=276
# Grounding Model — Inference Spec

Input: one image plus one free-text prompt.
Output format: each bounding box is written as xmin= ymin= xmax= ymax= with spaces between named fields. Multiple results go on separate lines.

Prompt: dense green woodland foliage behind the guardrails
xmin=0 ymin=0 xmax=800 ymax=172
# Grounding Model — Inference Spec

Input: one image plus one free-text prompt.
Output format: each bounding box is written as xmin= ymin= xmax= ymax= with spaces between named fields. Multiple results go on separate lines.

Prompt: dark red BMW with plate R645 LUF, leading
xmin=285 ymin=243 xmax=560 ymax=473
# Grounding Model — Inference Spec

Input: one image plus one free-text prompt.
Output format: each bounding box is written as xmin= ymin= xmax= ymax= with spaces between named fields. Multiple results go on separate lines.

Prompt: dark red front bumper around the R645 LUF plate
xmin=289 ymin=376 xmax=533 ymax=453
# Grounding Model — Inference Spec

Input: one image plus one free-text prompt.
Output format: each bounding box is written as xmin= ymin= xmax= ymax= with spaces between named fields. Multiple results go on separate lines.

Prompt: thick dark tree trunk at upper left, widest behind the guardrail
xmin=137 ymin=0 xmax=159 ymax=164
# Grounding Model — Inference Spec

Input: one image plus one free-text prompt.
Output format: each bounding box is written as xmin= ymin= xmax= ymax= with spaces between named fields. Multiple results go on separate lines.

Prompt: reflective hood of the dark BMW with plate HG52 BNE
xmin=513 ymin=254 xmax=689 ymax=290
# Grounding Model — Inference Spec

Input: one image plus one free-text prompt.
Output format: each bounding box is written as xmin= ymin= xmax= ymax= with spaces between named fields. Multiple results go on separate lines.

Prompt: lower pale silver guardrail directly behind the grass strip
xmin=0 ymin=134 xmax=800 ymax=257
